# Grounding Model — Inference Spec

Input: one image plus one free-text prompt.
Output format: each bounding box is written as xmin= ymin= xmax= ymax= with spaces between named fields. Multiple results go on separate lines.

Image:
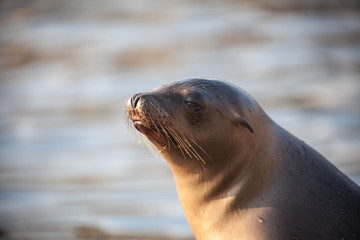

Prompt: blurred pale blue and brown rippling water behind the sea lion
xmin=0 ymin=0 xmax=360 ymax=240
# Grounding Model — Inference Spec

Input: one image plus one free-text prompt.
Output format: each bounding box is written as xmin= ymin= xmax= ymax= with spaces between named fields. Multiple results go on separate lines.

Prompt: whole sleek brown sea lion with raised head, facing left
xmin=127 ymin=78 xmax=360 ymax=240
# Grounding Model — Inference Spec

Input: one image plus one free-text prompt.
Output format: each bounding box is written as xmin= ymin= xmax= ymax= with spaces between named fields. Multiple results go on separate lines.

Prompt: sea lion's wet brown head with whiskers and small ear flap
xmin=127 ymin=78 xmax=265 ymax=168
